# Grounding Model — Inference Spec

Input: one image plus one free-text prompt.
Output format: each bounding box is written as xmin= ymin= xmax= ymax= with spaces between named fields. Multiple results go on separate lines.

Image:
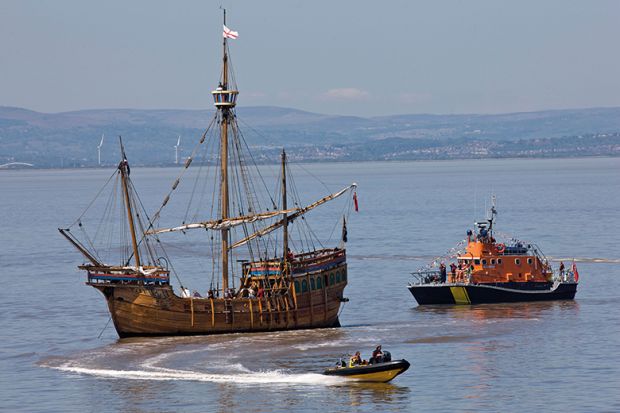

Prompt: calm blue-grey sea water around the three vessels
xmin=0 ymin=158 xmax=620 ymax=412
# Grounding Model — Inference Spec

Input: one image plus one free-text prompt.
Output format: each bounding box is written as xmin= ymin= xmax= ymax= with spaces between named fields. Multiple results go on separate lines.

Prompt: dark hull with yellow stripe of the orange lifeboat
xmin=409 ymin=282 xmax=577 ymax=305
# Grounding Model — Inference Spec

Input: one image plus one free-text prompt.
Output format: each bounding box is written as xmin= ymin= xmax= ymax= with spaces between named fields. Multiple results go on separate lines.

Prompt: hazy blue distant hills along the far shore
xmin=0 ymin=107 xmax=620 ymax=167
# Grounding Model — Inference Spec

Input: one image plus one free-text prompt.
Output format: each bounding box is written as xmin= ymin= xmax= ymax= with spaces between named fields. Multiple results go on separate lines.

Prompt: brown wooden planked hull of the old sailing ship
xmin=91 ymin=264 xmax=347 ymax=337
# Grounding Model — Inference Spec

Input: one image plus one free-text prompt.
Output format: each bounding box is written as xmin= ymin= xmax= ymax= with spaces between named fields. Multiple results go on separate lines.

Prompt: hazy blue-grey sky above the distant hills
xmin=0 ymin=0 xmax=620 ymax=117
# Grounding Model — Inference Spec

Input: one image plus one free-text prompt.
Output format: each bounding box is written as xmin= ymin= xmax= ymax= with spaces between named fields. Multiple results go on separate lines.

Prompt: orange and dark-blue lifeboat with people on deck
xmin=408 ymin=200 xmax=579 ymax=305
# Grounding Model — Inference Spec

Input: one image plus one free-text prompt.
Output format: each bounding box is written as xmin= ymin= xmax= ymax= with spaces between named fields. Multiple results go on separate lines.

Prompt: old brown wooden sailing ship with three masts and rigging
xmin=59 ymin=11 xmax=356 ymax=337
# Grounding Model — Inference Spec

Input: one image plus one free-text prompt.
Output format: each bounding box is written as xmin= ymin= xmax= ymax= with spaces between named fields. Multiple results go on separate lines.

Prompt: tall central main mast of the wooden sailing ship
xmin=211 ymin=9 xmax=239 ymax=291
